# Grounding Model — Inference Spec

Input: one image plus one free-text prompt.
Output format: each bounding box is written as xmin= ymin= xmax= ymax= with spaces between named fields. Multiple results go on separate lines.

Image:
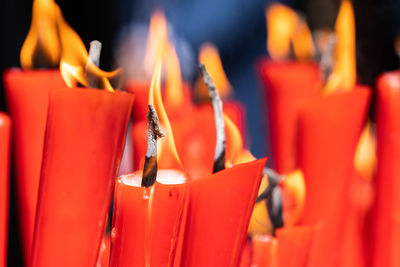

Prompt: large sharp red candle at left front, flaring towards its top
xmin=31 ymin=88 xmax=133 ymax=267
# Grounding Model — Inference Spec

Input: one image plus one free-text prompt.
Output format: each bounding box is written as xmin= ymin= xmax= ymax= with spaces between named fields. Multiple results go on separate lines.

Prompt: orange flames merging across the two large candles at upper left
xmin=21 ymin=0 xmax=120 ymax=91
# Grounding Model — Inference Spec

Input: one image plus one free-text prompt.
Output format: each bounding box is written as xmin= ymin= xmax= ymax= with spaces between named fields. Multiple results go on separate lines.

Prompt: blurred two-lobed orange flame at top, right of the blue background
xmin=265 ymin=3 xmax=314 ymax=60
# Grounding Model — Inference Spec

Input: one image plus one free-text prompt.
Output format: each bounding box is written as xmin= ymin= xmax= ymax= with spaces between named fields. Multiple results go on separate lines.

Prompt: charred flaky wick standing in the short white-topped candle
xmin=142 ymin=105 xmax=164 ymax=187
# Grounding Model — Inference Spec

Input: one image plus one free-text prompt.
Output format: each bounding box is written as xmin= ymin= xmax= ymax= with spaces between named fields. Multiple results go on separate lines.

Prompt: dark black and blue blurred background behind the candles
xmin=0 ymin=0 xmax=400 ymax=266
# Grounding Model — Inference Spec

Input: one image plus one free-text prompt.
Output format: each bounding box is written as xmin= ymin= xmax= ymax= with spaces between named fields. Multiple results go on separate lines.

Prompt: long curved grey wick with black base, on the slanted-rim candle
xmin=199 ymin=64 xmax=225 ymax=173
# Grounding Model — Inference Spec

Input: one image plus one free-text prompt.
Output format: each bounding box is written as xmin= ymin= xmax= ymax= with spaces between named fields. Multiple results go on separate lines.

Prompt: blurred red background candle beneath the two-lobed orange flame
xmin=258 ymin=59 xmax=322 ymax=173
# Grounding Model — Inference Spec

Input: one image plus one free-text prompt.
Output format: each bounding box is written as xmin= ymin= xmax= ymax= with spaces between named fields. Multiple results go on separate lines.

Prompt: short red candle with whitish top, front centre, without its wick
xmin=110 ymin=170 xmax=186 ymax=267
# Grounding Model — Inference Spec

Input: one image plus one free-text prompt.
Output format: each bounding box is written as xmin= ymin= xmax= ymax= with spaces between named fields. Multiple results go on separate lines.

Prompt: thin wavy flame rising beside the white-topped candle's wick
xmin=149 ymin=61 xmax=182 ymax=169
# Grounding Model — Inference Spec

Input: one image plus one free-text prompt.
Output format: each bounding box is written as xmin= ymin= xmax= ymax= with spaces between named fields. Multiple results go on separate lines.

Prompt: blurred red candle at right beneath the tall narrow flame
xmin=298 ymin=86 xmax=370 ymax=267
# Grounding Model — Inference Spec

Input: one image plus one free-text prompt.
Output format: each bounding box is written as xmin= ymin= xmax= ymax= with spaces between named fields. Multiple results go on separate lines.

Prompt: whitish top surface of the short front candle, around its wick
xmin=119 ymin=170 xmax=187 ymax=187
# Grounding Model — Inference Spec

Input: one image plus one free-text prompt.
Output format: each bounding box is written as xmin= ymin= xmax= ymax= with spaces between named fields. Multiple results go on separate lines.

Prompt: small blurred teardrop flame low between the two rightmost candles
xmin=354 ymin=123 xmax=377 ymax=181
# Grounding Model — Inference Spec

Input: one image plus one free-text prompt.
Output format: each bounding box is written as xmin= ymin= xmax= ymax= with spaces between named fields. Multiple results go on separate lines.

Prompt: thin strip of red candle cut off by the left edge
xmin=0 ymin=112 xmax=11 ymax=267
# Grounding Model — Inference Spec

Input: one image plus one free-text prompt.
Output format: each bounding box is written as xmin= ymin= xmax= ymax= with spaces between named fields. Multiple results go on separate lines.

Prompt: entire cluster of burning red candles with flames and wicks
xmin=0 ymin=0 xmax=400 ymax=267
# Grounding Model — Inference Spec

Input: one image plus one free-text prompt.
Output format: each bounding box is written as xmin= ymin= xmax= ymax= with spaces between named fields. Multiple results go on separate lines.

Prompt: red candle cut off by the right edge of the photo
xmin=371 ymin=71 xmax=400 ymax=267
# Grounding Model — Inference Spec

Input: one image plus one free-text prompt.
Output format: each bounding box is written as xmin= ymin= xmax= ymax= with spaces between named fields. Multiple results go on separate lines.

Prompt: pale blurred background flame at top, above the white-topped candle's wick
xmin=144 ymin=11 xmax=168 ymax=73
